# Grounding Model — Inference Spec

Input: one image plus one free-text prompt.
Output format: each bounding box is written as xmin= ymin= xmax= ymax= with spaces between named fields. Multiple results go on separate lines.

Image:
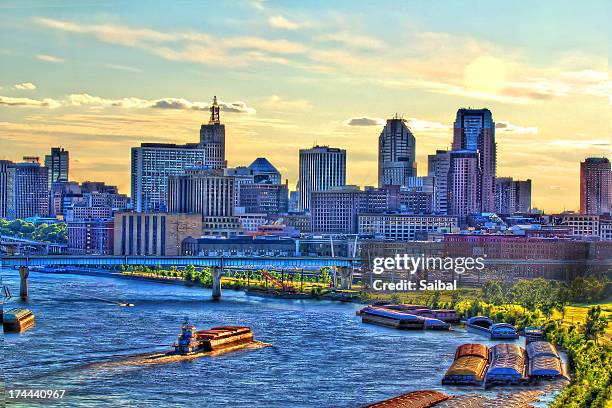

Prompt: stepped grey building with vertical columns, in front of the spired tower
xmin=167 ymin=167 xmax=240 ymax=236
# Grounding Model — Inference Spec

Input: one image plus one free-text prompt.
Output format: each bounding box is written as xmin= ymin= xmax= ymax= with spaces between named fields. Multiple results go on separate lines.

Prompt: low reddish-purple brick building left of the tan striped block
xmin=66 ymin=218 xmax=114 ymax=255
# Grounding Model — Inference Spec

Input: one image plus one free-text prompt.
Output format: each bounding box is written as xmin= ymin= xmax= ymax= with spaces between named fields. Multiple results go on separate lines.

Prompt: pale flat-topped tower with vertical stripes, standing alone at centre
xmin=298 ymin=146 xmax=346 ymax=211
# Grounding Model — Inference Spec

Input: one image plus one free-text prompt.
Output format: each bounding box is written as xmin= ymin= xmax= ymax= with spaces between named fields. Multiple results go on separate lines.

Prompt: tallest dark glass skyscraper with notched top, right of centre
xmin=453 ymin=108 xmax=497 ymax=212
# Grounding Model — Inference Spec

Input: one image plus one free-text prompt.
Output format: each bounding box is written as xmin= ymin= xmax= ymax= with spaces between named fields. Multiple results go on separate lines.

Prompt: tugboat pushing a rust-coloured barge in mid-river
xmin=174 ymin=322 xmax=253 ymax=355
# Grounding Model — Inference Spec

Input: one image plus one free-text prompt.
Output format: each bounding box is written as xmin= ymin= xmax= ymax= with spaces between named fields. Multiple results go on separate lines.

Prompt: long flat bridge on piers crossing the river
xmin=1 ymin=255 xmax=355 ymax=299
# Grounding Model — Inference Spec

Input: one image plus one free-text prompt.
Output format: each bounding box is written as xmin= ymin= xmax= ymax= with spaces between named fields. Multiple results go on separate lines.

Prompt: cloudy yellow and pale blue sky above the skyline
xmin=0 ymin=0 xmax=612 ymax=212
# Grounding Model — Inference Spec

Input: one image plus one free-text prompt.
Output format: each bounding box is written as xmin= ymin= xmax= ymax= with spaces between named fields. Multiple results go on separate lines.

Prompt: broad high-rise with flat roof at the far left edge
xmin=7 ymin=158 xmax=49 ymax=219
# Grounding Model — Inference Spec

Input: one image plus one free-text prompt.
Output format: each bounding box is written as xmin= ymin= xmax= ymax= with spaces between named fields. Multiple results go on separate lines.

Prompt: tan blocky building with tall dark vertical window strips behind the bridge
xmin=113 ymin=212 xmax=202 ymax=256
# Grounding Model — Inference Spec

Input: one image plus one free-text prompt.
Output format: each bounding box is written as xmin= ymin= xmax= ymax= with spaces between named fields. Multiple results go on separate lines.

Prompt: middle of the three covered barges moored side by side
xmin=485 ymin=343 xmax=527 ymax=386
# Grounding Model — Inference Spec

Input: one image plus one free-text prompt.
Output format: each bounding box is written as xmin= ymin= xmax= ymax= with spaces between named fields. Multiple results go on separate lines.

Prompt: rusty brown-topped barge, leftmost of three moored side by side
xmin=442 ymin=343 xmax=489 ymax=385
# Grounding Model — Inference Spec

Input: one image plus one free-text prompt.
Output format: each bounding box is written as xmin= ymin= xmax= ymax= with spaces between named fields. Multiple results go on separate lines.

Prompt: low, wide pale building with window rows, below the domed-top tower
xmin=358 ymin=214 xmax=458 ymax=241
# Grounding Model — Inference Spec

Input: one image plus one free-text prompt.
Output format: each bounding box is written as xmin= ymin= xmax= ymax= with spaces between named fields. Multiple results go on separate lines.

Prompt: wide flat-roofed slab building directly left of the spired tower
xmin=131 ymin=143 xmax=206 ymax=212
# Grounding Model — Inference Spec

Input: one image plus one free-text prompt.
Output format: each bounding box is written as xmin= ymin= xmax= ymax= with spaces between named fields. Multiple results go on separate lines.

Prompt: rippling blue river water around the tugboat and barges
xmin=2 ymin=269 xmax=564 ymax=407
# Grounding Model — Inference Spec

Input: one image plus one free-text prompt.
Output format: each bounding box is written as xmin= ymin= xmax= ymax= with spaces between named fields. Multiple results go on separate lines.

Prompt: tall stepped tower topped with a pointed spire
xmin=200 ymin=96 xmax=227 ymax=169
